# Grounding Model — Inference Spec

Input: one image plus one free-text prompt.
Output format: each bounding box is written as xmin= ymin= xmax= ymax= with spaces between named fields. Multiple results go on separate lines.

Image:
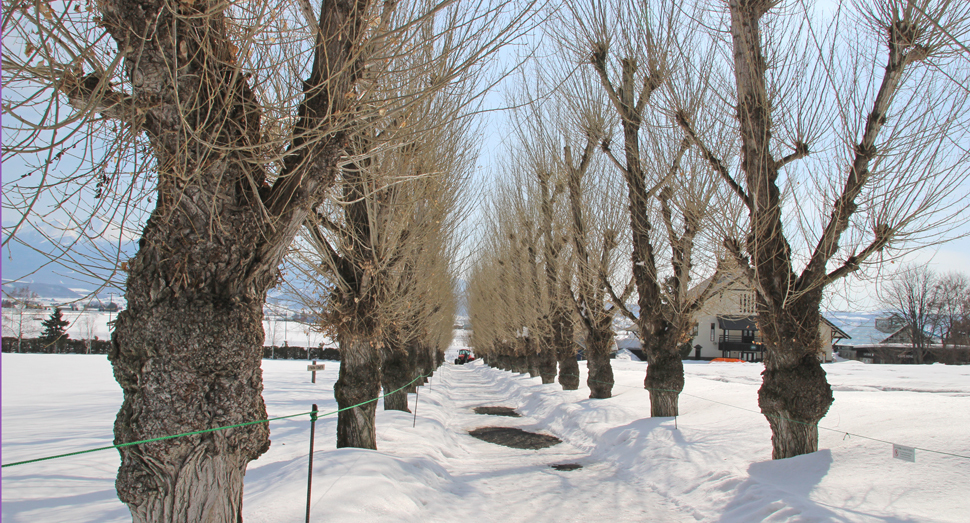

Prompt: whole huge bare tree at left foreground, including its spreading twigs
xmin=3 ymin=0 xmax=522 ymax=521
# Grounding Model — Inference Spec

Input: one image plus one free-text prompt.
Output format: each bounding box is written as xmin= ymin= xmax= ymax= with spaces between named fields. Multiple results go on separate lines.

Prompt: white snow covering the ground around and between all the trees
xmin=2 ymin=339 xmax=970 ymax=523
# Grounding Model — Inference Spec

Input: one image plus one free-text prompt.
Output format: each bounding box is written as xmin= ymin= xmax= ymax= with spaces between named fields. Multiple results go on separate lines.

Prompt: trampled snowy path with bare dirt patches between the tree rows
xmin=408 ymin=362 xmax=688 ymax=521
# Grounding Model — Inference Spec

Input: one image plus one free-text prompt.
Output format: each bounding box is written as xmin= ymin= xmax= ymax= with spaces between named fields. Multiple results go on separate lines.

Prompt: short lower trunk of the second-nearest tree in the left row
xmin=333 ymin=336 xmax=381 ymax=450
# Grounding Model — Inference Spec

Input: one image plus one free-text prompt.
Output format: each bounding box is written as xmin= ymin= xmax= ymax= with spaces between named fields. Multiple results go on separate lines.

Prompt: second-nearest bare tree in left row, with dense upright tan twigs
xmin=299 ymin=40 xmax=474 ymax=448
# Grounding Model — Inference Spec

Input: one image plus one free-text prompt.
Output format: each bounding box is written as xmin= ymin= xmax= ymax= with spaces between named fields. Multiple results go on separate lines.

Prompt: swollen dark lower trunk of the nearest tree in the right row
xmin=758 ymin=347 xmax=834 ymax=459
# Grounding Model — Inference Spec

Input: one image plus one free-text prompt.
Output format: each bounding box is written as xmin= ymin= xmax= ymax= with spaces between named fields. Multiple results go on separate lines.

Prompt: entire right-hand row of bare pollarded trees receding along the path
xmin=469 ymin=0 xmax=970 ymax=458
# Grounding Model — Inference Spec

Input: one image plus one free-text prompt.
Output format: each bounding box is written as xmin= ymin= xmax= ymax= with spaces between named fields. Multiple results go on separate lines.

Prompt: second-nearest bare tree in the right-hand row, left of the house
xmin=564 ymin=1 xmax=715 ymax=416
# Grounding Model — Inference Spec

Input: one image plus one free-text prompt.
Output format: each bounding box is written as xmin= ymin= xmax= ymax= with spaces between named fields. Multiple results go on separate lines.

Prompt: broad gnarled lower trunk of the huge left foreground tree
xmin=109 ymin=296 xmax=269 ymax=523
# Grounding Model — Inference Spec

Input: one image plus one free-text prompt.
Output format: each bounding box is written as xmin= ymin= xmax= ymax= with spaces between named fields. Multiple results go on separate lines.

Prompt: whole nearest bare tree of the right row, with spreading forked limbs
xmin=676 ymin=0 xmax=970 ymax=459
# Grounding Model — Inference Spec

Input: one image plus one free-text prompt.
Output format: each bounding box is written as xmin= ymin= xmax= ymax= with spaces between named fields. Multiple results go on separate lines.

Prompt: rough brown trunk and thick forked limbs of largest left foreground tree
xmin=90 ymin=0 xmax=367 ymax=522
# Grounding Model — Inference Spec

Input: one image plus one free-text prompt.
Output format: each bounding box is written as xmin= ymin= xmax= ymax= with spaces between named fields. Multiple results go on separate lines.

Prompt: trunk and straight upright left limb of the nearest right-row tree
xmin=729 ymin=0 xmax=833 ymax=459
